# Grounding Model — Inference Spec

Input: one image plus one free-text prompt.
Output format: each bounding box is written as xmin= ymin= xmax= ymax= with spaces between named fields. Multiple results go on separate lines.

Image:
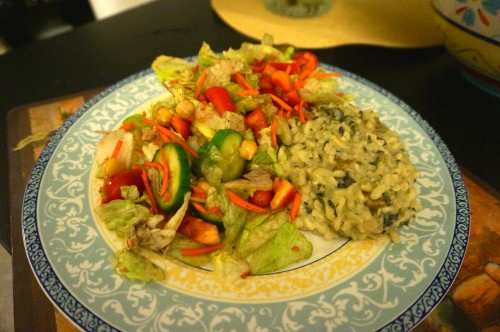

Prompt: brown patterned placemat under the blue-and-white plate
xmin=8 ymin=89 xmax=500 ymax=331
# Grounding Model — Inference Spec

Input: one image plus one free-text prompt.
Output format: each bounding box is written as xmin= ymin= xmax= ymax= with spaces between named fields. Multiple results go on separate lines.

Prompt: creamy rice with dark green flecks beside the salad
xmin=280 ymin=103 xmax=419 ymax=239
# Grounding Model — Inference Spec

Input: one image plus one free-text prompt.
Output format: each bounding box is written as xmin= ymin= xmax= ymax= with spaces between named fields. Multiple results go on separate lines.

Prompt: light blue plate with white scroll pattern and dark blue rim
xmin=22 ymin=65 xmax=469 ymax=331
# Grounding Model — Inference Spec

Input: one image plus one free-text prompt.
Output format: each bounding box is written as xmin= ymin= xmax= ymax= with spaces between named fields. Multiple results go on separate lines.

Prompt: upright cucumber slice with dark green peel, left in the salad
xmin=153 ymin=142 xmax=191 ymax=212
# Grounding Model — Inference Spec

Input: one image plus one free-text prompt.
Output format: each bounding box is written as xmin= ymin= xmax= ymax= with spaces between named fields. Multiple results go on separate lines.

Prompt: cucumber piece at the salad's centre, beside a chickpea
xmin=210 ymin=129 xmax=247 ymax=182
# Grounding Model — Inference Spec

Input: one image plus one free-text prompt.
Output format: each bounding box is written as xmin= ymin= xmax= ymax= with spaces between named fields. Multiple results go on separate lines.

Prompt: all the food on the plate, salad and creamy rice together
xmin=95 ymin=36 xmax=418 ymax=281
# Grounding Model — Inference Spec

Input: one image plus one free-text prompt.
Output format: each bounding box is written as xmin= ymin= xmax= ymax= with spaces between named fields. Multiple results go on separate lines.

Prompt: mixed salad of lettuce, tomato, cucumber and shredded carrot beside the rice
xmin=95 ymin=36 xmax=414 ymax=281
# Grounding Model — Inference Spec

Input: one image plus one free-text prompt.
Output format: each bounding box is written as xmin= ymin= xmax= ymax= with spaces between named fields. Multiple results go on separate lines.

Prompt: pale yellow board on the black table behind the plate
xmin=211 ymin=0 xmax=441 ymax=49
